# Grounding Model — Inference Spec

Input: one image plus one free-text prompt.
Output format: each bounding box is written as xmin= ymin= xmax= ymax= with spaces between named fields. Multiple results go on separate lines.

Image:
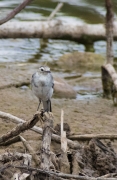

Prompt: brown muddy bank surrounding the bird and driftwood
xmin=0 ymin=52 xmax=117 ymax=177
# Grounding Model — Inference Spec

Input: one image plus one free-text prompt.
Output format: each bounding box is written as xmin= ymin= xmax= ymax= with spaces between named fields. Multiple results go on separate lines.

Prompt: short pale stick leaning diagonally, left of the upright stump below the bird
xmin=20 ymin=136 xmax=40 ymax=166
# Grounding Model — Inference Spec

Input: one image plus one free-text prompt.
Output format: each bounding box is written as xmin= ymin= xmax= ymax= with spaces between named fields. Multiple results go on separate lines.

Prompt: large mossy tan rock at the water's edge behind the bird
xmin=50 ymin=52 xmax=105 ymax=72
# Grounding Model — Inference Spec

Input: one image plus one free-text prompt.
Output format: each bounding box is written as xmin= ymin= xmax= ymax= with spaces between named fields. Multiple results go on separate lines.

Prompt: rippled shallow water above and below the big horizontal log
xmin=0 ymin=0 xmax=117 ymax=99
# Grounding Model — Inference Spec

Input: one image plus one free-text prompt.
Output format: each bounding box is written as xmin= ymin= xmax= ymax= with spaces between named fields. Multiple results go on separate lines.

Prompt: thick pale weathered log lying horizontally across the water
xmin=0 ymin=20 xmax=117 ymax=43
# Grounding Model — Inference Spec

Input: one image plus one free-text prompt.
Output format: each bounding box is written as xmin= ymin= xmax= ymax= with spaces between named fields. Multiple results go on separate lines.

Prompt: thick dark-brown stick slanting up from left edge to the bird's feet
xmin=0 ymin=113 xmax=42 ymax=143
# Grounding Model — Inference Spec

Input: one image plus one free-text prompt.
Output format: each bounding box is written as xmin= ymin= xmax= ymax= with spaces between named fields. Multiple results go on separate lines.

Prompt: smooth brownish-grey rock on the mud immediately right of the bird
xmin=54 ymin=77 xmax=77 ymax=98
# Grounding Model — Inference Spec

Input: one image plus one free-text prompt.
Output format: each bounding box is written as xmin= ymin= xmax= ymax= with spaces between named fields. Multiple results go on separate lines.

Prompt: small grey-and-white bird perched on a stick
xmin=31 ymin=66 xmax=54 ymax=112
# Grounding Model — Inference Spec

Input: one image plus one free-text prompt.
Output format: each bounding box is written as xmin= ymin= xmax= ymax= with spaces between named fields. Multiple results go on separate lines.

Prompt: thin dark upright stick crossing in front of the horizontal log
xmin=105 ymin=0 xmax=114 ymax=64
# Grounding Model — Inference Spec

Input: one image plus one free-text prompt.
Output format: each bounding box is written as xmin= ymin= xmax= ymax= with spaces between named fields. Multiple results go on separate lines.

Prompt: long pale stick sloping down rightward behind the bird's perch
xmin=0 ymin=111 xmax=82 ymax=149
